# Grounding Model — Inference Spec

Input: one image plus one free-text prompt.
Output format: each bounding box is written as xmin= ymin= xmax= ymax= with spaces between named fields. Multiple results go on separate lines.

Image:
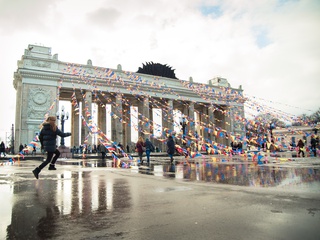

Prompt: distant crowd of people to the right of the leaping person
xmin=70 ymin=132 xmax=319 ymax=165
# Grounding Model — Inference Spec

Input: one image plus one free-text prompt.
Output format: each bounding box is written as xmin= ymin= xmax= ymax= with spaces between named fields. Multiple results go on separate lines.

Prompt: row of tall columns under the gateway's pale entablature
xmin=71 ymin=91 xmax=232 ymax=149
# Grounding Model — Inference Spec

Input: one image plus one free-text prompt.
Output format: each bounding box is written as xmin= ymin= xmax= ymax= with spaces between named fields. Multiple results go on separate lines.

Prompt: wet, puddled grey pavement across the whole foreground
xmin=0 ymin=158 xmax=320 ymax=239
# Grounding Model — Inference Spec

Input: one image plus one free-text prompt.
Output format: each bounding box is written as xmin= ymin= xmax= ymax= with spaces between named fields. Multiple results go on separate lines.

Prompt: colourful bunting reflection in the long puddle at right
xmin=154 ymin=162 xmax=320 ymax=189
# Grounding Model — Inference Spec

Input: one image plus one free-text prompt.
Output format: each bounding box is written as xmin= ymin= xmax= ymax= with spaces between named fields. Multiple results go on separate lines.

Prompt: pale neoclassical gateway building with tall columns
xmin=13 ymin=45 xmax=245 ymax=151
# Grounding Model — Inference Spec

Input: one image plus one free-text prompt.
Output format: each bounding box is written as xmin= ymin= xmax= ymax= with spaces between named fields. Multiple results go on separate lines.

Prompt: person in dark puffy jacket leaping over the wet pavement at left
xmin=32 ymin=116 xmax=71 ymax=179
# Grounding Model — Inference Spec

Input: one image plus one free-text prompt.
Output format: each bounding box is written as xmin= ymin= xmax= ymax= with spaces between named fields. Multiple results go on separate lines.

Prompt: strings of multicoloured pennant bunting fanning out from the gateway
xmin=13 ymin=63 xmax=316 ymax=167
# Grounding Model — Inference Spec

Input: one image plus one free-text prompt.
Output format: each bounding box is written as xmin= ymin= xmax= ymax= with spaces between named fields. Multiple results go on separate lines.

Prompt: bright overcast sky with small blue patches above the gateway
xmin=0 ymin=0 xmax=320 ymax=140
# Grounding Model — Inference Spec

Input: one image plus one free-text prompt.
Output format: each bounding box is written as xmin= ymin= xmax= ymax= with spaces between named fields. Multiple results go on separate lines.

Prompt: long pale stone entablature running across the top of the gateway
xmin=14 ymin=52 xmax=242 ymax=108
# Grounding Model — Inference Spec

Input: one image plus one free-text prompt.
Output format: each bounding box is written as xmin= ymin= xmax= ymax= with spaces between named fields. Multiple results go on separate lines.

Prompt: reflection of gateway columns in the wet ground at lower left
xmin=0 ymin=171 xmax=132 ymax=239
